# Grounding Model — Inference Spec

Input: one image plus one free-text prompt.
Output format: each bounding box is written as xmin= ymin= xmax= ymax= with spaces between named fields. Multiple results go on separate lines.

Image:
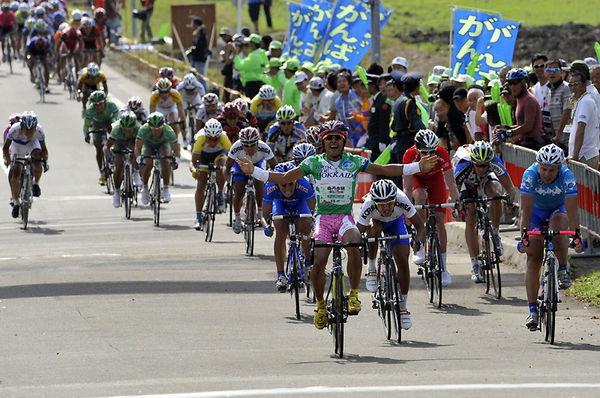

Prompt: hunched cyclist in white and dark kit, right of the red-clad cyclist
xmin=454 ymin=141 xmax=517 ymax=283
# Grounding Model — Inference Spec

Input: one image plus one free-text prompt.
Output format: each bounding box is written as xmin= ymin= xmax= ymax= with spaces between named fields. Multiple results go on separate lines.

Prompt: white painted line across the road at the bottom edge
xmin=98 ymin=383 xmax=600 ymax=398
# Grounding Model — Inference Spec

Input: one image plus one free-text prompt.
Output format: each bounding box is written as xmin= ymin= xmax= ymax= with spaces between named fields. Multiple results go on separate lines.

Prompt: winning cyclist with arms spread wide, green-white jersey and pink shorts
xmin=238 ymin=121 xmax=437 ymax=329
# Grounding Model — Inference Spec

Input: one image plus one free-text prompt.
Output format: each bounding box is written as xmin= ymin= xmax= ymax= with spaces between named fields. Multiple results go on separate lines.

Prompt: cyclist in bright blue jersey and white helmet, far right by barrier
xmin=519 ymin=144 xmax=583 ymax=331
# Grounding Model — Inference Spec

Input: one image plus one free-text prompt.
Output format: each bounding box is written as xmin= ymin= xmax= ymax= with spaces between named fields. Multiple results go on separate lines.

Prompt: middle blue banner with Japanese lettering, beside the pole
xmin=320 ymin=0 xmax=392 ymax=70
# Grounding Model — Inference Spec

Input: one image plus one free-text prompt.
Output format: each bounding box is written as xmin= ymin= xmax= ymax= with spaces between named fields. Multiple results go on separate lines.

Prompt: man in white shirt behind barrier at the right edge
xmin=565 ymin=63 xmax=600 ymax=170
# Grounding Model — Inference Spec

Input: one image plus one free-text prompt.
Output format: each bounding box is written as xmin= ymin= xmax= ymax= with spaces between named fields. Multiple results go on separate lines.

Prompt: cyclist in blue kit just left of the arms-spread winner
xmin=262 ymin=162 xmax=316 ymax=293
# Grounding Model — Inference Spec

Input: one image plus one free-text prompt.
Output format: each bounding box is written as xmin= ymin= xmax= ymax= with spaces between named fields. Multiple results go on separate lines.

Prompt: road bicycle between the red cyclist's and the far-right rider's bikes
xmin=464 ymin=195 xmax=510 ymax=299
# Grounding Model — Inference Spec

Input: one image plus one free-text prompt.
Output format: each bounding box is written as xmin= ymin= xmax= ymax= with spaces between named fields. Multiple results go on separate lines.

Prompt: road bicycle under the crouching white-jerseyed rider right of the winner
xmin=367 ymin=234 xmax=411 ymax=343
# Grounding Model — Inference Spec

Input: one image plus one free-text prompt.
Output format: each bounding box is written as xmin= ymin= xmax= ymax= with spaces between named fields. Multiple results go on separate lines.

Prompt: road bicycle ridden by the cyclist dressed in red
xmin=415 ymin=203 xmax=455 ymax=308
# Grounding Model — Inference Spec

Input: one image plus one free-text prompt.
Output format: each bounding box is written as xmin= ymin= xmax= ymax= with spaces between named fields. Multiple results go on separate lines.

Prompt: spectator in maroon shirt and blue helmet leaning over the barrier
xmin=495 ymin=69 xmax=545 ymax=151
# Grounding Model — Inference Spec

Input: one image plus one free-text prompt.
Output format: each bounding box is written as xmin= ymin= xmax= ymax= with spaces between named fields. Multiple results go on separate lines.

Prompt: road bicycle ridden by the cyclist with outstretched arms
xmin=311 ymin=237 xmax=367 ymax=358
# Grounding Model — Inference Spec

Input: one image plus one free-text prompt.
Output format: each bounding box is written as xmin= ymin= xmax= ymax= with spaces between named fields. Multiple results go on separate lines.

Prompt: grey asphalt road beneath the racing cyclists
xmin=0 ymin=56 xmax=600 ymax=397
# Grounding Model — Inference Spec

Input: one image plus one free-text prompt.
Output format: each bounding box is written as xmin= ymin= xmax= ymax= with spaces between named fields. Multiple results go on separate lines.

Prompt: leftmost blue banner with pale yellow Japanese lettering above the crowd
xmin=283 ymin=0 xmax=333 ymax=63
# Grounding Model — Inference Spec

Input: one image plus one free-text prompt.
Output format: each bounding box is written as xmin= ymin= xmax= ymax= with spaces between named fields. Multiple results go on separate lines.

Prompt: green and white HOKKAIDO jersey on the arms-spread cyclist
xmin=298 ymin=152 xmax=369 ymax=215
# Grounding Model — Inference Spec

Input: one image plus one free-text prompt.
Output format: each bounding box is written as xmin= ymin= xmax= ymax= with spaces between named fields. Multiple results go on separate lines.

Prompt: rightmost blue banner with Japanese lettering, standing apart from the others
xmin=452 ymin=9 xmax=519 ymax=80
